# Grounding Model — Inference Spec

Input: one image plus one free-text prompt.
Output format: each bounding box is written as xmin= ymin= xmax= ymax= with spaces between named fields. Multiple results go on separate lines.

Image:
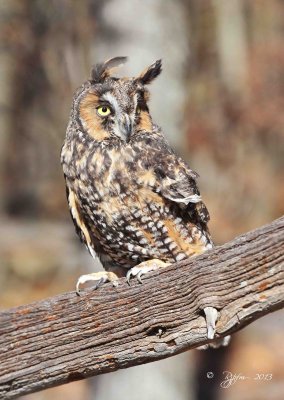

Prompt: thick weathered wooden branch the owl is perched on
xmin=0 ymin=218 xmax=284 ymax=399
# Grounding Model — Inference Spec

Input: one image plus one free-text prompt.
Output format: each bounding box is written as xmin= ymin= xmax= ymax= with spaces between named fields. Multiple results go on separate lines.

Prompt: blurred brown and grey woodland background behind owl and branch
xmin=0 ymin=0 xmax=284 ymax=400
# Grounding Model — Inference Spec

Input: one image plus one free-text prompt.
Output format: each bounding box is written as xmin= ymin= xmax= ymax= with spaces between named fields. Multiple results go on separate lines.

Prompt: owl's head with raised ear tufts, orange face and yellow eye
xmin=76 ymin=57 xmax=162 ymax=142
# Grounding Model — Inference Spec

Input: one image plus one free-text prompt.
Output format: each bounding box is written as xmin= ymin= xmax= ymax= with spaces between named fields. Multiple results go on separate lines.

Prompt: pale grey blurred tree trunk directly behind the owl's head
xmin=91 ymin=0 xmax=189 ymax=146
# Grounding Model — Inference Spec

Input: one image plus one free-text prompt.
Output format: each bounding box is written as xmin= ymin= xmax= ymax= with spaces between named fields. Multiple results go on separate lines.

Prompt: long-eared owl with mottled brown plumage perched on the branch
xmin=61 ymin=57 xmax=212 ymax=291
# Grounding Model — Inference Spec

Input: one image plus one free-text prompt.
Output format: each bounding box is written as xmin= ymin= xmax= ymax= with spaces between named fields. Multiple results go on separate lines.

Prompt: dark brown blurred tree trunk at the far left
xmin=5 ymin=0 xmax=49 ymax=215
